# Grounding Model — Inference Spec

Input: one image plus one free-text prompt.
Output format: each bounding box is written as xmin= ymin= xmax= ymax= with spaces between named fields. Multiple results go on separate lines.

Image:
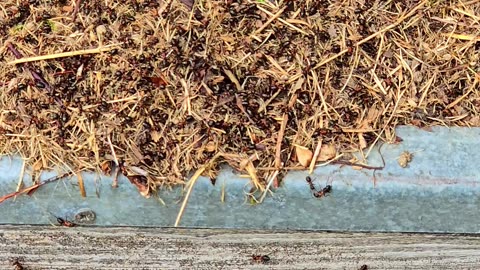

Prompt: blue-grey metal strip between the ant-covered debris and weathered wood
xmin=0 ymin=127 xmax=480 ymax=233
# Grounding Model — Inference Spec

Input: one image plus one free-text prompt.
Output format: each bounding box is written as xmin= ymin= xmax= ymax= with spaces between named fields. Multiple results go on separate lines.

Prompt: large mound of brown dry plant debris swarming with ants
xmin=0 ymin=0 xmax=480 ymax=196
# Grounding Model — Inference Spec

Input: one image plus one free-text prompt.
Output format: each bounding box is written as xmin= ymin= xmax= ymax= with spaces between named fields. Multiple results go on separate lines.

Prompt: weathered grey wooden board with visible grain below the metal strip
xmin=0 ymin=226 xmax=480 ymax=269
